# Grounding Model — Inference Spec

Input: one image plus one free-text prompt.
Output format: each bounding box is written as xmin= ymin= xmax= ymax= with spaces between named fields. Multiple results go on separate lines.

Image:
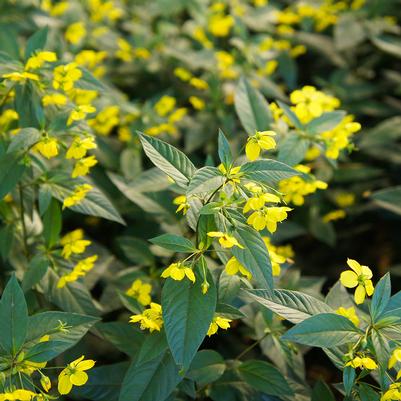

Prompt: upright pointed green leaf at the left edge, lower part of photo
xmin=0 ymin=275 xmax=28 ymax=355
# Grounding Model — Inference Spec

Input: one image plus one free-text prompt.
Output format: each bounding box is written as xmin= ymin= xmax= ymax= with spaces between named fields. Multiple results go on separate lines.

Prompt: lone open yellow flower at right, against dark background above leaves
xmin=340 ymin=259 xmax=374 ymax=304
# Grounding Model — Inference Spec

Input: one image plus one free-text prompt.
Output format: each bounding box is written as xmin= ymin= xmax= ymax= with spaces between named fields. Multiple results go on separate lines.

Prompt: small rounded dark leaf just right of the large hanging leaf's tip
xmin=186 ymin=350 xmax=226 ymax=387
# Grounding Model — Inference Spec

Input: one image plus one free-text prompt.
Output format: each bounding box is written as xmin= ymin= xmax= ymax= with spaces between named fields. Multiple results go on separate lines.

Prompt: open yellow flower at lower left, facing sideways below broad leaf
xmin=58 ymin=355 xmax=95 ymax=394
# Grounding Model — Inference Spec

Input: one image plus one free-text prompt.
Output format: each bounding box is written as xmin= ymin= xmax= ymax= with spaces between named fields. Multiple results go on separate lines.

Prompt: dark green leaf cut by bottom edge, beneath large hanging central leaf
xmin=119 ymin=351 xmax=183 ymax=401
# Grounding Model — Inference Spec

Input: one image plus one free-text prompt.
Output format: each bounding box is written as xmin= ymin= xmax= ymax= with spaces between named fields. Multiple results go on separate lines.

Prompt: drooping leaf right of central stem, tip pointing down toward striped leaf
xmin=231 ymin=224 xmax=273 ymax=290
